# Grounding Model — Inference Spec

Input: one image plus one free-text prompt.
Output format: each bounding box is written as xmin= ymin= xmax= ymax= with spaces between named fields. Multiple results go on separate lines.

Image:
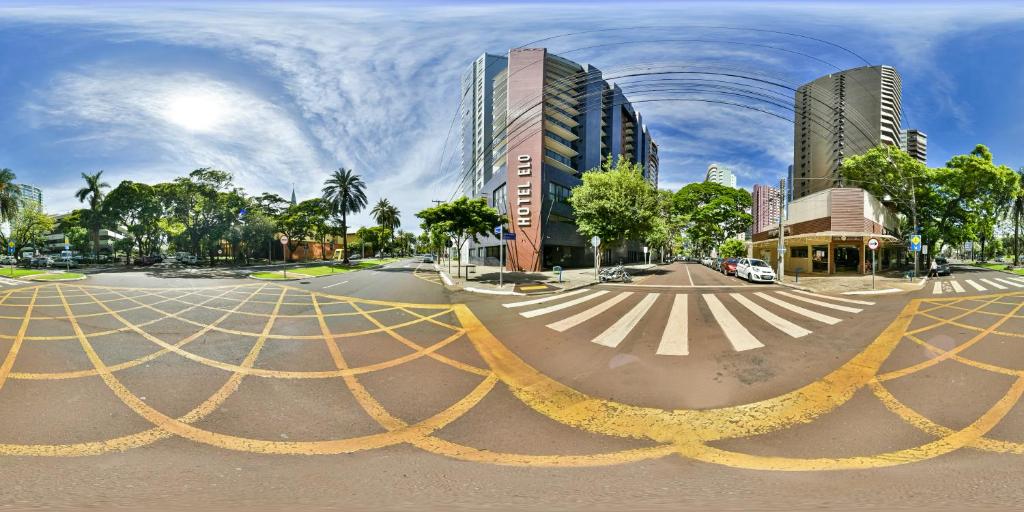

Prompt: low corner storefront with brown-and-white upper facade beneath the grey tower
xmin=751 ymin=188 xmax=905 ymax=275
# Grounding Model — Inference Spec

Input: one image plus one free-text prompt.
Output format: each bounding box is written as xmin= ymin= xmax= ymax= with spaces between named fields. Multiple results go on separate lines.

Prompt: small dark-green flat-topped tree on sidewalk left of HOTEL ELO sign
xmin=416 ymin=196 xmax=505 ymax=276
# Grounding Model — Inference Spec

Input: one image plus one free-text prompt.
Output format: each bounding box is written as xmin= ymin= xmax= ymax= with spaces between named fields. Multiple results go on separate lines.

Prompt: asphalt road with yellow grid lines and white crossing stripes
xmin=0 ymin=261 xmax=1024 ymax=510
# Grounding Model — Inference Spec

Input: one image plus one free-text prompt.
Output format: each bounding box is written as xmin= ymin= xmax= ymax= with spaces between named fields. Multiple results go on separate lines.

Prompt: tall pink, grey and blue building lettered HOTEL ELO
xmin=460 ymin=48 xmax=658 ymax=271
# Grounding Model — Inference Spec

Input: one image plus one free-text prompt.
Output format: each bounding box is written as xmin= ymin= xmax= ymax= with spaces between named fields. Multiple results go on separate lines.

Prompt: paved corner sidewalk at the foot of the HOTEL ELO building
xmin=437 ymin=261 xmax=656 ymax=295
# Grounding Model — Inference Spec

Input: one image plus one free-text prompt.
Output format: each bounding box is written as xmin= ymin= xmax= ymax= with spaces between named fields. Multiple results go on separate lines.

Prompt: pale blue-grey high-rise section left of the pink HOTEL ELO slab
xmin=461 ymin=53 xmax=508 ymax=198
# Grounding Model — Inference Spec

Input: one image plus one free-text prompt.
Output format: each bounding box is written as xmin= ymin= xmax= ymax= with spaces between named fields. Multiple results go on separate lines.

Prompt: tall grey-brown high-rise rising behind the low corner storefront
xmin=793 ymin=66 xmax=901 ymax=199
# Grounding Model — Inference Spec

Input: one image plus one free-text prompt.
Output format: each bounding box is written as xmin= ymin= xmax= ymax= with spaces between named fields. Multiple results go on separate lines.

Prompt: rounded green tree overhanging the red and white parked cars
xmin=674 ymin=181 xmax=753 ymax=258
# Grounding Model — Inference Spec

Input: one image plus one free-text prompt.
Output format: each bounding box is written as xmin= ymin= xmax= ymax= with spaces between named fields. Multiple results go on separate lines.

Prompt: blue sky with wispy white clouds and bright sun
xmin=0 ymin=0 xmax=1024 ymax=230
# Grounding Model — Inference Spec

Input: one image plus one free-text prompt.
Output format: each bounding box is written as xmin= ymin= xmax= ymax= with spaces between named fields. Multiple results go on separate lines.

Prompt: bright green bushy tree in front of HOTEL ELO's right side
xmin=569 ymin=157 xmax=658 ymax=264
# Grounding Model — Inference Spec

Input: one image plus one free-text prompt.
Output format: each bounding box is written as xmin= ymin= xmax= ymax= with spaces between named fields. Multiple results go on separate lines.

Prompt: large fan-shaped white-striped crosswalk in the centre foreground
xmin=503 ymin=289 xmax=874 ymax=355
